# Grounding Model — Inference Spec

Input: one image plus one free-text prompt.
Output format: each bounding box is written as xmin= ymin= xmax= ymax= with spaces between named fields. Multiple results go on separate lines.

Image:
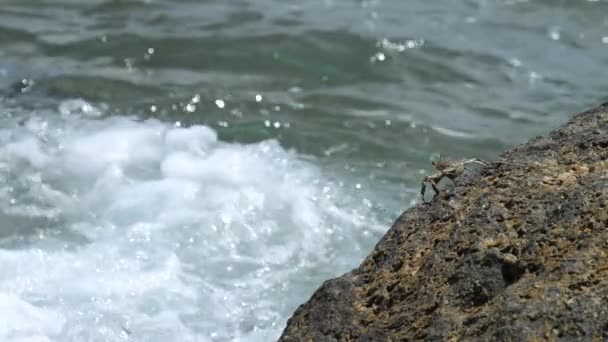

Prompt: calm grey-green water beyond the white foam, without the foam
xmin=0 ymin=0 xmax=608 ymax=191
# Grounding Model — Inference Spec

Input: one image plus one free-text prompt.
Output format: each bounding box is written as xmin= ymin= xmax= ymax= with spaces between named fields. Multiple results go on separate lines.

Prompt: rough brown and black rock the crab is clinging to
xmin=281 ymin=103 xmax=608 ymax=341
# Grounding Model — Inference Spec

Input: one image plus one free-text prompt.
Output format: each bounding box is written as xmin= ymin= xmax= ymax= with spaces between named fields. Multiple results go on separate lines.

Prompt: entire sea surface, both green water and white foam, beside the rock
xmin=0 ymin=0 xmax=608 ymax=341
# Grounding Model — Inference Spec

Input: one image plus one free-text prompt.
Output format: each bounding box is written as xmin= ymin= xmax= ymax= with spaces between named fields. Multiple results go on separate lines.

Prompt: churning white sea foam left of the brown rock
xmin=0 ymin=102 xmax=379 ymax=341
